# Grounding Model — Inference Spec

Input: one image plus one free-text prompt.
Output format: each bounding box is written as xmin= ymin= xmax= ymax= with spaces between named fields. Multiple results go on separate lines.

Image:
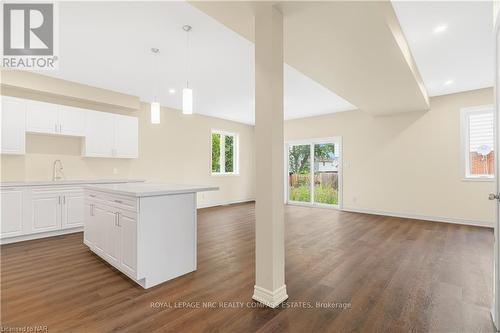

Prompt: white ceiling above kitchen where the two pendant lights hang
xmin=42 ymin=2 xmax=355 ymax=124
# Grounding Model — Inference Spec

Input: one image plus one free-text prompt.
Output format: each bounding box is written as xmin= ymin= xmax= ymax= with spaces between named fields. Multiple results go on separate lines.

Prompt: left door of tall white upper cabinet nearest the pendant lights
xmin=84 ymin=111 xmax=115 ymax=157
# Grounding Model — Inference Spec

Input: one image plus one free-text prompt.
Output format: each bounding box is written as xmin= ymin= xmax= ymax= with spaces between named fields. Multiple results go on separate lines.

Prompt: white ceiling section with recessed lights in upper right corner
xmin=392 ymin=1 xmax=494 ymax=96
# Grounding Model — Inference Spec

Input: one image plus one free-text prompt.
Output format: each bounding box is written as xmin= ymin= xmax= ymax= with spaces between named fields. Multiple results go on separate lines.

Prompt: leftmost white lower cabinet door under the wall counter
xmin=0 ymin=187 xmax=24 ymax=237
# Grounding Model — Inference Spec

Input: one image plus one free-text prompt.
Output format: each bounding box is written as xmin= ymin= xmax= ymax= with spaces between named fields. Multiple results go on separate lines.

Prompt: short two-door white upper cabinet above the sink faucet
xmin=26 ymin=101 xmax=85 ymax=136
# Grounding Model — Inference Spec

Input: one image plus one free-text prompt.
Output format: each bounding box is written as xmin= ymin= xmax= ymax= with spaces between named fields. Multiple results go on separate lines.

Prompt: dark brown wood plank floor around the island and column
xmin=1 ymin=204 xmax=494 ymax=332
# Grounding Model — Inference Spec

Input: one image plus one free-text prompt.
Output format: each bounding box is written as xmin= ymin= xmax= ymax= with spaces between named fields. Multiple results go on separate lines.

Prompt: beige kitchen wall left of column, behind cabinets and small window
xmin=1 ymin=87 xmax=255 ymax=206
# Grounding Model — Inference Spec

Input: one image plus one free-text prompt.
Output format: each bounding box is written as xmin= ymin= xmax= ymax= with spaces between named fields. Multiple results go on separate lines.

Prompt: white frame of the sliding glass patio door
xmin=284 ymin=136 xmax=344 ymax=210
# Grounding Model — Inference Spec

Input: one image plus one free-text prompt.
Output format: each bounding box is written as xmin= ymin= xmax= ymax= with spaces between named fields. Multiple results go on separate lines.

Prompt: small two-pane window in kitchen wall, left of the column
xmin=211 ymin=130 xmax=238 ymax=175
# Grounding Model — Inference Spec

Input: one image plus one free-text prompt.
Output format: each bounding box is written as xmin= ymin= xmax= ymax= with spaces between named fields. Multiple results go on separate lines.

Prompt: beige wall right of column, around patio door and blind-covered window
xmin=285 ymin=88 xmax=495 ymax=224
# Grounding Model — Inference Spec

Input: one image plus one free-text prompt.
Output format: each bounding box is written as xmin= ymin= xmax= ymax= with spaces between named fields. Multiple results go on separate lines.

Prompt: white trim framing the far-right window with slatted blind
xmin=460 ymin=105 xmax=497 ymax=182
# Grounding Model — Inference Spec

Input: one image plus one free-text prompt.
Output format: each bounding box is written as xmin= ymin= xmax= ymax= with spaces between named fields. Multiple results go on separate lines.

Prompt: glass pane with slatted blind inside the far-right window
xmin=469 ymin=112 xmax=495 ymax=176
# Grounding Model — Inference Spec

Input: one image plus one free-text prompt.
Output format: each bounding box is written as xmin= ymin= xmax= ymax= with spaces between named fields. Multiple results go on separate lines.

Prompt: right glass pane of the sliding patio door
xmin=314 ymin=143 xmax=339 ymax=205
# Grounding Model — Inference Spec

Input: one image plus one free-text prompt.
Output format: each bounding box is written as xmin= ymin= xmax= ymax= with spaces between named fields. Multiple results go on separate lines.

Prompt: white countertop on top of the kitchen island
xmin=85 ymin=183 xmax=219 ymax=197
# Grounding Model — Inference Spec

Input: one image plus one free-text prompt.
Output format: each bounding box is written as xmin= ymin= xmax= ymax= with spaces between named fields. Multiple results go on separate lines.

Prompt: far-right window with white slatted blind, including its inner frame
xmin=461 ymin=106 xmax=495 ymax=180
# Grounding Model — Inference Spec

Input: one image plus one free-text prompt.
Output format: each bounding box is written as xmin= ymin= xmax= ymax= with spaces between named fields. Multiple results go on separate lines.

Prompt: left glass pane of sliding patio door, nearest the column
xmin=288 ymin=145 xmax=311 ymax=202
